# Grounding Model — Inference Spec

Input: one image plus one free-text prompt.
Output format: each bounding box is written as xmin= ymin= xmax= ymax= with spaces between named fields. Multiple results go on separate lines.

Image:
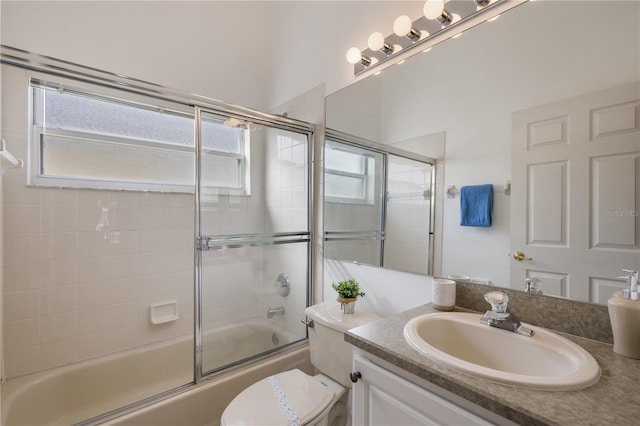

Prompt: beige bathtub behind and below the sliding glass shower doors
xmin=1 ymin=323 xmax=313 ymax=426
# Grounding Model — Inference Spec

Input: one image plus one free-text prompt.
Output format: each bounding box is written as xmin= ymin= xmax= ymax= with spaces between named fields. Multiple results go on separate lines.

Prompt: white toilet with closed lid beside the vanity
xmin=221 ymin=300 xmax=380 ymax=426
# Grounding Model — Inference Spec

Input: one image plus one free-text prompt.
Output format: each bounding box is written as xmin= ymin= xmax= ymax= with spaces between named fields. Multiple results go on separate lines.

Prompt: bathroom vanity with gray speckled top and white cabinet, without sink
xmin=345 ymin=304 xmax=640 ymax=425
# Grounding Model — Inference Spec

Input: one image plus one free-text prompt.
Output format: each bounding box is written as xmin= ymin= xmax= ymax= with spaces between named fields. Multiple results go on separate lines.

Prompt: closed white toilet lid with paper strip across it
xmin=221 ymin=369 xmax=334 ymax=426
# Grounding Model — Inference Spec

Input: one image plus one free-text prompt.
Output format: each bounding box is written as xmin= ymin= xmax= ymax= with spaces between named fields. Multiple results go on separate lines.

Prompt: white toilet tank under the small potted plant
xmin=305 ymin=300 xmax=380 ymax=388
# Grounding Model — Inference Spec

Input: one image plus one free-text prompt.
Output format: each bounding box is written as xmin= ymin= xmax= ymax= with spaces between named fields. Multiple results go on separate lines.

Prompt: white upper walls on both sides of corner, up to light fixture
xmin=0 ymin=0 xmax=422 ymax=110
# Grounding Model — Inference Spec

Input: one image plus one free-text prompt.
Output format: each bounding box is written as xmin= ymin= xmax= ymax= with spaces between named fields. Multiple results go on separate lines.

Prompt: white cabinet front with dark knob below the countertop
xmin=352 ymin=355 xmax=491 ymax=426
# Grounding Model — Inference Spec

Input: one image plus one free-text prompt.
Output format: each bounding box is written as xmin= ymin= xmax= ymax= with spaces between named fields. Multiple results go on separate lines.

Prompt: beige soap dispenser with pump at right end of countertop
xmin=607 ymin=269 xmax=640 ymax=359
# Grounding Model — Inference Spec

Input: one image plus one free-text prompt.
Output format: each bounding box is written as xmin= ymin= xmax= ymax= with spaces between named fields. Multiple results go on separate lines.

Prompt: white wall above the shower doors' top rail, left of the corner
xmin=0 ymin=1 xmax=270 ymax=109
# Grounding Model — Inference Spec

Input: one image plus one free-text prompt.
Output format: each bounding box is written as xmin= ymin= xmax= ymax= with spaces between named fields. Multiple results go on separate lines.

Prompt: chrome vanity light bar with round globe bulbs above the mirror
xmin=347 ymin=0 xmax=529 ymax=76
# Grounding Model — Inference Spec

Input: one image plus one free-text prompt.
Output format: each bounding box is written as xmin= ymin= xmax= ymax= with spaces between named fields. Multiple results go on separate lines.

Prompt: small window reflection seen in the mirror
xmin=324 ymin=140 xmax=376 ymax=205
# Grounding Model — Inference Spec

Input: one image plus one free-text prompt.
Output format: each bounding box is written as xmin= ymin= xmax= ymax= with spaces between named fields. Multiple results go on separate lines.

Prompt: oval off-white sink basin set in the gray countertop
xmin=404 ymin=312 xmax=600 ymax=390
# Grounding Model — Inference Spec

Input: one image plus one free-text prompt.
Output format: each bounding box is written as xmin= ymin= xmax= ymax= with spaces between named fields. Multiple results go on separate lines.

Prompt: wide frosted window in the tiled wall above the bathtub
xmin=30 ymin=78 xmax=249 ymax=194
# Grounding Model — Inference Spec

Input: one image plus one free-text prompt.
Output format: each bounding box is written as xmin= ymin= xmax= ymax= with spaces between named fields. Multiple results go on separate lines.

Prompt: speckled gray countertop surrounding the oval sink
xmin=345 ymin=304 xmax=640 ymax=426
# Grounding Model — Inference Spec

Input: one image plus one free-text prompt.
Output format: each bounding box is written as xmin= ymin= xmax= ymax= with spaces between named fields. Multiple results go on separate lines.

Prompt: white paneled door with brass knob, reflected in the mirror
xmin=510 ymin=82 xmax=640 ymax=303
